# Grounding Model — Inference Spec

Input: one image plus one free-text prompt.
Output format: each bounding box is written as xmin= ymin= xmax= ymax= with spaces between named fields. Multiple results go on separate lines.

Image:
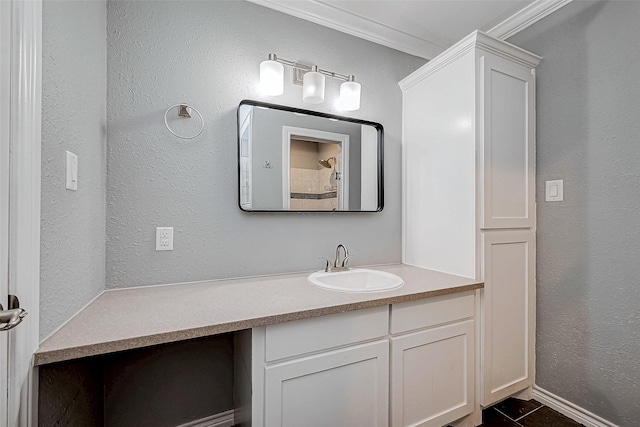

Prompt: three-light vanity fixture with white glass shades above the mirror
xmin=260 ymin=53 xmax=361 ymax=111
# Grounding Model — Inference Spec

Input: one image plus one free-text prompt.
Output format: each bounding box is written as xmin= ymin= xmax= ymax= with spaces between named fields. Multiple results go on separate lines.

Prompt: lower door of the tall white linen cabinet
xmin=480 ymin=230 xmax=535 ymax=406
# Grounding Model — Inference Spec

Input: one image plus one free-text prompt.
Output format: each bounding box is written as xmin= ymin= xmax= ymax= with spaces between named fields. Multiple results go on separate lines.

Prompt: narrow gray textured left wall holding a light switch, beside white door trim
xmin=40 ymin=1 xmax=107 ymax=338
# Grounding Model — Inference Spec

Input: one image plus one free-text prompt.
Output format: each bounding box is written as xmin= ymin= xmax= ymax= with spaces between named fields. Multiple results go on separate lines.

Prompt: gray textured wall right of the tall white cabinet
xmin=509 ymin=1 xmax=640 ymax=426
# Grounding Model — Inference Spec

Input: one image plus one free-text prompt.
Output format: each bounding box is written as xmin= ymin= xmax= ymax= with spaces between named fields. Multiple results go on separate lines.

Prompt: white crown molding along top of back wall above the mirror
xmin=248 ymin=0 xmax=446 ymax=59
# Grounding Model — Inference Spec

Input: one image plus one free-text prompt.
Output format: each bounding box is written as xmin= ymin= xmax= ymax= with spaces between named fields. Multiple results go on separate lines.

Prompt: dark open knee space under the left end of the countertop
xmin=38 ymin=334 xmax=233 ymax=427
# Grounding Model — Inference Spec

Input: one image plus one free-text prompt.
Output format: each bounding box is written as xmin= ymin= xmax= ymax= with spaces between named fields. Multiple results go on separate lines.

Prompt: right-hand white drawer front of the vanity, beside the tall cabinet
xmin=391 ymin=292 xmax=474 ymax=334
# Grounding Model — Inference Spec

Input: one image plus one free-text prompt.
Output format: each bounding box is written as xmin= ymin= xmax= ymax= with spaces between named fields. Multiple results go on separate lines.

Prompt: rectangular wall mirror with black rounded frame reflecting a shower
xmin=238 ymin=101 xmax=383 ymax=212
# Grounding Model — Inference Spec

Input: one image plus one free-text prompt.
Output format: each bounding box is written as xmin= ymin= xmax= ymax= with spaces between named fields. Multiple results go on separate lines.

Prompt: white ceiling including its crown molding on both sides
xmin=249 ymin=0 xmax=571 ymax=59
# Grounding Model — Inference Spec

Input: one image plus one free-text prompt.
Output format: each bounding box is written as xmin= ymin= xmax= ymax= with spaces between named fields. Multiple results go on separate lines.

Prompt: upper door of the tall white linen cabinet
xmin=478 ymin=54 xmax=535 ymax=228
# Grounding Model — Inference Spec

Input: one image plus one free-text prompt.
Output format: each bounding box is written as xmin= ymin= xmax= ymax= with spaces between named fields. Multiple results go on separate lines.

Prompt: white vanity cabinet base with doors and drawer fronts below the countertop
xmin=236 ymin=291 xmax=476 ymax=427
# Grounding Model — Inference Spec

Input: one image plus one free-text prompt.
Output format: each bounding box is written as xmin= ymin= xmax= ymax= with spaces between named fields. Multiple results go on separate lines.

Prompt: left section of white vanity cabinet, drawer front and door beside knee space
xmin=242 ymin=306 xmax=389 ymax=427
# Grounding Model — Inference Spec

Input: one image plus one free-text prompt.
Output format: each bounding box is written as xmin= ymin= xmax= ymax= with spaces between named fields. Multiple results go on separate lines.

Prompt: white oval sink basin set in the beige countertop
xmin=307 ymin=268 xmax=404 ymax=292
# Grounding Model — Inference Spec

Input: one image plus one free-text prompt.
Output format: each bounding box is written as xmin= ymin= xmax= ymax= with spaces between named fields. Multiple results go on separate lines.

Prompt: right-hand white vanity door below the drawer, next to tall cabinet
xmin=391 ymin=320 xmax=475 ymax=427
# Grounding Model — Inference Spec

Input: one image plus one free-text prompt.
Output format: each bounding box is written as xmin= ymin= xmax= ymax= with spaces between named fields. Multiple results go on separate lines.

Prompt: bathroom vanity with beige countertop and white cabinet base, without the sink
xmin=34 ymin=265 xmax=483 ymax=427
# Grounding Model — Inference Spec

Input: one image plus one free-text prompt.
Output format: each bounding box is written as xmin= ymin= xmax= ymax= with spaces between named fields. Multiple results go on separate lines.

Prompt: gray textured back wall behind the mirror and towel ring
xmin=106 ymin=1 xmax=424 ymax=288
